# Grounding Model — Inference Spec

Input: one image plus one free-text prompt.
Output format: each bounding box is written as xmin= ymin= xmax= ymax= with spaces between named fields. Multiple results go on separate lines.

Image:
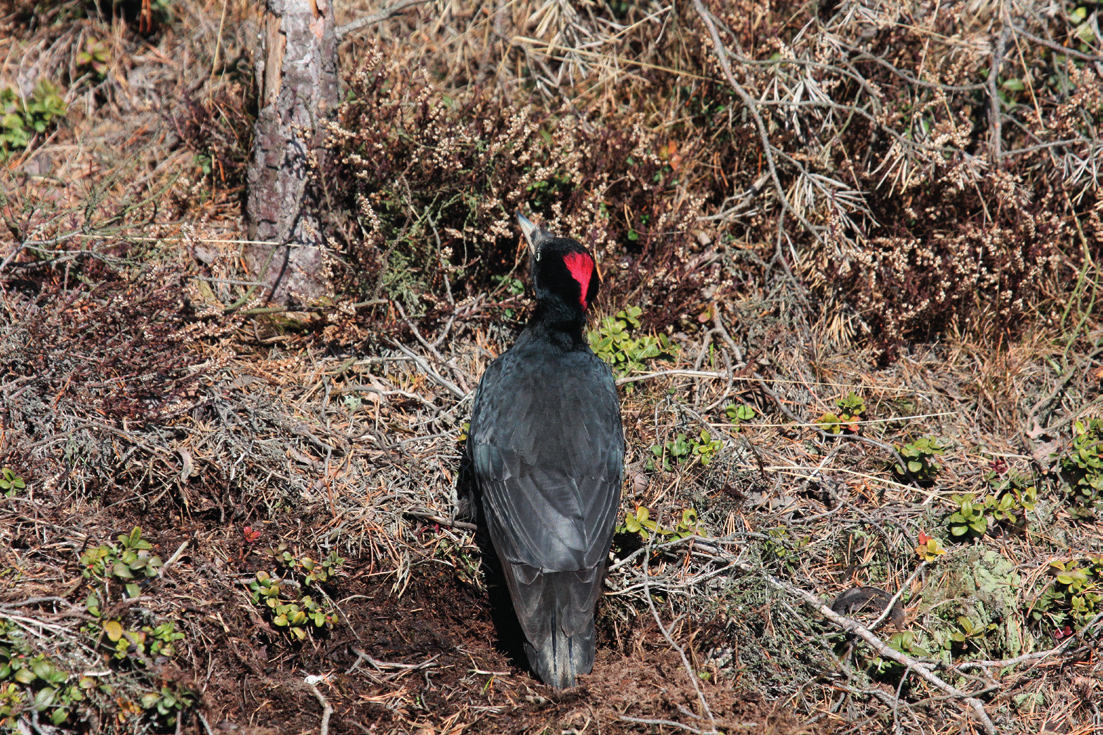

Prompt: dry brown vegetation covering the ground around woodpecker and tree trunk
xmin=0 ymin=0 xmax=1103 ymax=733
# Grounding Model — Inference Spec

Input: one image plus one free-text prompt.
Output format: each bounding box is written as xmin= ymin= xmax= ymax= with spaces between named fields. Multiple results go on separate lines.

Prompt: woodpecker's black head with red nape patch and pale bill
xmin=517 ymin=212 xmax=601 ymax=319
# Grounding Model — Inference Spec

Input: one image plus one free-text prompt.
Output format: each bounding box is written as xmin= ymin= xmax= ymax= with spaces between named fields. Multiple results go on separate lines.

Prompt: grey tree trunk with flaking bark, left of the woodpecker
xmin=245 ymin=0 xmax=338 ymax=305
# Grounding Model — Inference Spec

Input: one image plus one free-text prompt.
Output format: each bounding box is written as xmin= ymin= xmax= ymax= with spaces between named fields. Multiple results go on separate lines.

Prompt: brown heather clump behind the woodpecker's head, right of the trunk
xmin=331 ymin=47 xmax=698 ymax=327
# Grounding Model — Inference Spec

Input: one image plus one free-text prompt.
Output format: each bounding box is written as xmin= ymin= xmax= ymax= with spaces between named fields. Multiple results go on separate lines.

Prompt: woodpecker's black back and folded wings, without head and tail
xmin=468 ymin=332 xmax=624 ymax=572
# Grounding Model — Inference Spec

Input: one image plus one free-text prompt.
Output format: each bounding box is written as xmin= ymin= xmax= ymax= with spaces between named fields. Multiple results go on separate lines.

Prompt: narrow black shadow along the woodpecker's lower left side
xmin=456 ymin=457 xmax=531 ymax=671
